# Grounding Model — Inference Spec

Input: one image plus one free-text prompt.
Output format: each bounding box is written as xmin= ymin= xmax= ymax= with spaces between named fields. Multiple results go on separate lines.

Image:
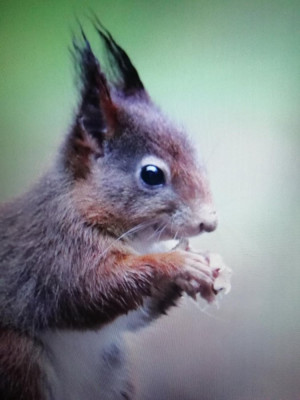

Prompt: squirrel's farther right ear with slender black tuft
xmin=94 ymin=16 xmax=146 ymax=96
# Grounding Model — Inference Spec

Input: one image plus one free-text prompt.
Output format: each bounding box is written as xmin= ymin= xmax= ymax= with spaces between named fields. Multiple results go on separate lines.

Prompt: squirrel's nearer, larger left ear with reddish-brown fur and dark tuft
xmin=64 ymin=31 xmax=117 ymax=178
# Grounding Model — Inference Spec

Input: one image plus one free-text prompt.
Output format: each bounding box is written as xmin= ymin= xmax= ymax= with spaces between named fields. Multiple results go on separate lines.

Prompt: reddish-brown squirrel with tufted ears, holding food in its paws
xmin=0 ymin=22 xmax=231 ymax=400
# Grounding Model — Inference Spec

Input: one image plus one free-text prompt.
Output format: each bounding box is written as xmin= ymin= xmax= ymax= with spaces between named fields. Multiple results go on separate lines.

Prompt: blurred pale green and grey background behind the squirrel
xmin=0 ymin=0 xmax=300 ymax=400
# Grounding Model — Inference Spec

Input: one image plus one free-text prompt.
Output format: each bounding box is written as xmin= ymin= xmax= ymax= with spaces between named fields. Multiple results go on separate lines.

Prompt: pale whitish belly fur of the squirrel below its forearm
xmin=41 ymin=317 xmax=133 ymax=400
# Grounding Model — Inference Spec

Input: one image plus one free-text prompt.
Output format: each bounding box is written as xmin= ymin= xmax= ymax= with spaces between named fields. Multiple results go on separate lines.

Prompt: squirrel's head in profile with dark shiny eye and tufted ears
xmin=63 ymin=23 xmax=217 ymax=240
